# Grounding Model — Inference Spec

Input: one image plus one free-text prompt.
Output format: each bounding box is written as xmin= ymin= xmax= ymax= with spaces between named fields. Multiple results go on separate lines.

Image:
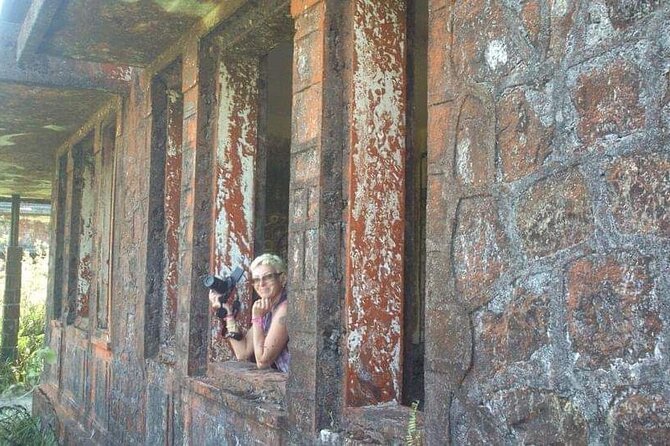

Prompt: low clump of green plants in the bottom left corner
xmin=0 ymin=406 xmax=58 ymax=446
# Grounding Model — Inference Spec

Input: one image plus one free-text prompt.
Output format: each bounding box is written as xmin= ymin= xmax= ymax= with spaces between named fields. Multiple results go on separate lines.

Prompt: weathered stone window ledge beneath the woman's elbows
xmin=185 ymin=361 xmax=287 ymax=428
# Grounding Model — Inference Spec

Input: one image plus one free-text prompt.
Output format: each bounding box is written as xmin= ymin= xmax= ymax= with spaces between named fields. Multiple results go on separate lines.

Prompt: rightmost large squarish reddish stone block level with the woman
xmin=566 ymin=252 xmax=663 ymax=369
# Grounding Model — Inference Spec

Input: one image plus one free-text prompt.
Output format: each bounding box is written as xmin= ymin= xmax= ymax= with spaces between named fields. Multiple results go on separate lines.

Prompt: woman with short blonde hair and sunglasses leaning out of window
xmin=209 ymin=254 xmax=290 ymax=372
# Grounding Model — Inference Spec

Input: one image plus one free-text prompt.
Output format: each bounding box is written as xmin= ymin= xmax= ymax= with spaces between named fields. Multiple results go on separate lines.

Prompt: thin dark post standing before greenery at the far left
xmin=0 ymin=195 xmax=23 ymax=361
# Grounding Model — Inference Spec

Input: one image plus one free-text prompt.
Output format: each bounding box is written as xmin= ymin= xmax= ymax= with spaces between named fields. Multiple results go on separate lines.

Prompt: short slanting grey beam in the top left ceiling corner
xmin=16 ymin=0 xmax=62 ymax=66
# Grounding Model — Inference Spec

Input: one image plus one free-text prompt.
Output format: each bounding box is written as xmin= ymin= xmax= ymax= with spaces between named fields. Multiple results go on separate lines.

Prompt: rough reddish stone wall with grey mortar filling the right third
xmin=425 ymin=1 xmax=670 ymax=444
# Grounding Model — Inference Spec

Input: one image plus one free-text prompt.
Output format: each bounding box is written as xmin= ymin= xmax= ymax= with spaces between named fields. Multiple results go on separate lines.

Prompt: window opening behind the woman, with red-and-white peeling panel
xmin=208 ymin=28 xmax=293 ymax=363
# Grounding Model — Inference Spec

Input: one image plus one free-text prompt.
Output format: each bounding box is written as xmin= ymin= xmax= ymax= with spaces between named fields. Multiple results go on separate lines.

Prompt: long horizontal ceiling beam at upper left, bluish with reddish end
xmin=0 ymin=22 xmax=137 ymax=94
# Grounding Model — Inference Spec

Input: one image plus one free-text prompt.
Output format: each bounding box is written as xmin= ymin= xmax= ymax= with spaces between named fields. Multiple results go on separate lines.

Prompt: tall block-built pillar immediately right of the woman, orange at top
xmin=286 ymin=0 xmax=348 ymax=441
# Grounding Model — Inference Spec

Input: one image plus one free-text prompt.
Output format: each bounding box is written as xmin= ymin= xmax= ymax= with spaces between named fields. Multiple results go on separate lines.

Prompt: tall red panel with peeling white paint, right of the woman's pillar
xmin=347 ymin=0 xmax=405 ymax=406
